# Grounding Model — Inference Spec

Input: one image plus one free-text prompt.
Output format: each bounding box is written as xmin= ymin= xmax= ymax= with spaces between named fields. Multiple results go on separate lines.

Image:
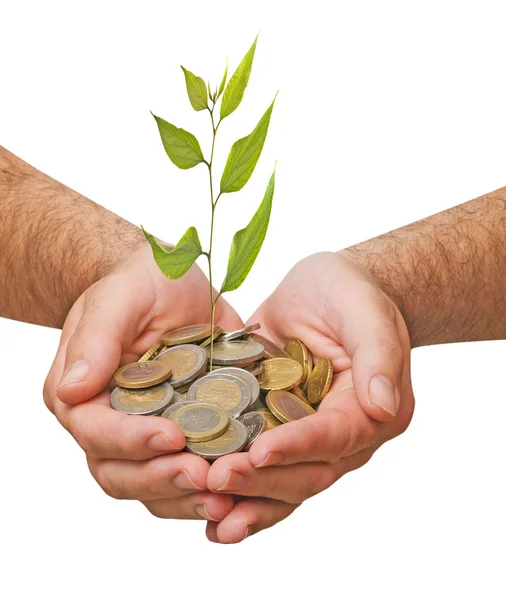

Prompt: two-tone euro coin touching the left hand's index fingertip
xmin=169 ymin=402 xmax=230 ymax=442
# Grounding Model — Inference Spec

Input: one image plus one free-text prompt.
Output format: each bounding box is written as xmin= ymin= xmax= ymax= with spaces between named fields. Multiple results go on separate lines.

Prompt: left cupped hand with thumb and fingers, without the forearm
xmin=44 ymin=244 xmax=242 ymax=520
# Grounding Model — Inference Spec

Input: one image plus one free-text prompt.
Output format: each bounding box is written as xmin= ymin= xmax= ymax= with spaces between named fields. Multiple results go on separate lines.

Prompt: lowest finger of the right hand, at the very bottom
xmin=206 ymin=498 xmax=297 ymax=544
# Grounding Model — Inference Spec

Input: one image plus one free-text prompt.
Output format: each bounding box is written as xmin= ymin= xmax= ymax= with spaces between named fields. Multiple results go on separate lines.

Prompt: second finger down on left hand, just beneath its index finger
xmin=88 ymin=452 xmax=209 ymax=501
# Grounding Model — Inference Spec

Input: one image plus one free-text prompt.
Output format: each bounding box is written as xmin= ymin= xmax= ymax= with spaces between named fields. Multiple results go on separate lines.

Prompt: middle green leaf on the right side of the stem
xmin=220 ymin=98 xmax=276 ymax=194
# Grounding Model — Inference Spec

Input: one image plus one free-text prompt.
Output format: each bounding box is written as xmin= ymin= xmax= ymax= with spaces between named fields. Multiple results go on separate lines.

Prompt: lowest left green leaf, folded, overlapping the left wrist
xmin=142 ymin=227 xmax=203 ymax=279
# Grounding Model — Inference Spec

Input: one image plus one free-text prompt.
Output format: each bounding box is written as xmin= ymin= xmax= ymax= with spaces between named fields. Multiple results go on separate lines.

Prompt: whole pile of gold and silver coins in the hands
xmin=111 ymin=324 xmax=333 ymax=461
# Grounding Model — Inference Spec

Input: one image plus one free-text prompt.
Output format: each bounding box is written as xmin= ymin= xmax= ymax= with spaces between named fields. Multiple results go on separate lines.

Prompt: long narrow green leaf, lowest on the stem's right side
xmin=220 ymin=171 xmax=276 ymax=294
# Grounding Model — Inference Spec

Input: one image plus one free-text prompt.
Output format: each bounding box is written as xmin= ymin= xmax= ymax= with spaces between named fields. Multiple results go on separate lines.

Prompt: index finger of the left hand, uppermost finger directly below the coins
xmin=55 ymin=392 xmax=185 ymax=460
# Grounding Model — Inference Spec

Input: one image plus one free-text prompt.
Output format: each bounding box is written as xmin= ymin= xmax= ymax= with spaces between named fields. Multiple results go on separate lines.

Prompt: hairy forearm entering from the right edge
xmin=342 ymin=188 xmax=506 ymax=347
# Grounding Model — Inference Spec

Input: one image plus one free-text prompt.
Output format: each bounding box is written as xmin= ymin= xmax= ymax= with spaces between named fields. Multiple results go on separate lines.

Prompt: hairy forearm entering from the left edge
xmin=0 ymin=146 xmax=145 ymax=327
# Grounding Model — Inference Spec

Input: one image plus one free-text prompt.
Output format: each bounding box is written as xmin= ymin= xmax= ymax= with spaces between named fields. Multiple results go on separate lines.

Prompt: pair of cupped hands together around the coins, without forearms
xmin=44 ymin=244 xmax=414 ymax=543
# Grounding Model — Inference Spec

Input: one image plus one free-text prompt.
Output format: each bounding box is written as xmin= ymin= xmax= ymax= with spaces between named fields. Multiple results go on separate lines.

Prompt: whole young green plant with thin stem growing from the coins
xmin=143 ymin=36 xmax=276 ymax=368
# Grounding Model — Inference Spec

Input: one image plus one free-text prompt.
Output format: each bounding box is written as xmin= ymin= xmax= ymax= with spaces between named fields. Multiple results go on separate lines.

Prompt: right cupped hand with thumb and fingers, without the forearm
xmin=207 ymin=253 xmax=414 ymax=543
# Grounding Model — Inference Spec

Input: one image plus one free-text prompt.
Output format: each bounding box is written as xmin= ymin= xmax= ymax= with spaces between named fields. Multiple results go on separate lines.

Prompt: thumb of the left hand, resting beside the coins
xmin=57 ymin=276 xmax=150 ymax=404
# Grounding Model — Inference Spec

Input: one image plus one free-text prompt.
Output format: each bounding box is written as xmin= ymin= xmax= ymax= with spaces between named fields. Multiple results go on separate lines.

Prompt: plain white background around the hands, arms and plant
xmin=0 ymin=0 xmax=506 ymax=600
